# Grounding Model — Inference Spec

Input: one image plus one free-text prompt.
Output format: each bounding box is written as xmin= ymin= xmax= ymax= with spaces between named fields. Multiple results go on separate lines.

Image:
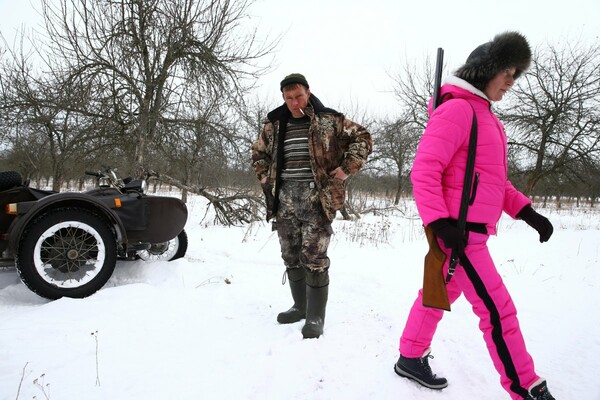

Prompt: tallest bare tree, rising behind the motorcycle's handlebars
xmin=42 ymin=0 xmax=273 ymax=175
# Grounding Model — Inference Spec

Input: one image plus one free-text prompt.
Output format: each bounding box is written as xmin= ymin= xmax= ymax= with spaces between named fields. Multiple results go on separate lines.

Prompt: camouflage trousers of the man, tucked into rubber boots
xmin=277 ymin=181 xmax=333 ymax=282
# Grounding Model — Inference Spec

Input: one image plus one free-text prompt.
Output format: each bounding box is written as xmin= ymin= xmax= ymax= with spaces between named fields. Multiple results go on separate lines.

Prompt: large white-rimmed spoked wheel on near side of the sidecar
xmin=16 ymin=209 xmax=117 ymax=299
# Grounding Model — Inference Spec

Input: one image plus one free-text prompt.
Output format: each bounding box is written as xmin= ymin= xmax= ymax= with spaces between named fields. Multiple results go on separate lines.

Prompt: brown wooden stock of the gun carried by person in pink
xmin=423 ymin=227 xmax=450 ymax=311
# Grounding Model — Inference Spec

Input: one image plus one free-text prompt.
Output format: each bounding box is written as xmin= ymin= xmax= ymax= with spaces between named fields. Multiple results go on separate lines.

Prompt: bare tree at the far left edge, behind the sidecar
xmin=0 ymin=38 xmax=120 ymax=191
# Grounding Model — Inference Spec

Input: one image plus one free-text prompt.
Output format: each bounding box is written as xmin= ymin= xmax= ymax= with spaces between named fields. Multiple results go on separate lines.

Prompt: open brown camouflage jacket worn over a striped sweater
xmin=252 ymin=94 xmax=372 ymax=221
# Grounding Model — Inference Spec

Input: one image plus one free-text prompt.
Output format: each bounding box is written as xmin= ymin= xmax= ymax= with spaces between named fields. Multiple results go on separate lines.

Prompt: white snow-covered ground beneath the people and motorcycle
xmin=0 ymin=193 xmax=600 ymax=400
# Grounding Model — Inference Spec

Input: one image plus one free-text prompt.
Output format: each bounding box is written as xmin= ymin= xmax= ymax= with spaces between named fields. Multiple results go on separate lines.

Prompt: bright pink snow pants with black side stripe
xmin=400 ymin=232 xmax=539 ymax=399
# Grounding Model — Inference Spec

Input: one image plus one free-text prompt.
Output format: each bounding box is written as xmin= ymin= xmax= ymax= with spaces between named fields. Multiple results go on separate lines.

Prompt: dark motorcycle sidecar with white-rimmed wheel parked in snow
xmin=0 ymin=171 xmax=187 ymax=299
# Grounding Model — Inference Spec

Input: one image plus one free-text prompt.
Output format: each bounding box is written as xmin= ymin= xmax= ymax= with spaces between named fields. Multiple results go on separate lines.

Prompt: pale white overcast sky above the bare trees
xmin=0 ymin=0 xmax=600 ymax=115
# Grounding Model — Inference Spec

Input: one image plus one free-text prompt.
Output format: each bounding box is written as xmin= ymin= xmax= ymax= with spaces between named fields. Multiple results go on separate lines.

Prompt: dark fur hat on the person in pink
xmin=454 ymin=32 xmax=531 ymax=92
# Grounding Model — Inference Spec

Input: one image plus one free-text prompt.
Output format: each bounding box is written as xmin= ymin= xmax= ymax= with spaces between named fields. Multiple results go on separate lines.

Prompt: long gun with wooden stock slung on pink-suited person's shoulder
xmin=423 ymin=47 xmax=450 ymax=311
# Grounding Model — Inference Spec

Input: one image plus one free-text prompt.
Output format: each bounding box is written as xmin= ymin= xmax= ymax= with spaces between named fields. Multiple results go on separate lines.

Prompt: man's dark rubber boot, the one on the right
xmin=302 ymin=271 xmax=329 ymax=339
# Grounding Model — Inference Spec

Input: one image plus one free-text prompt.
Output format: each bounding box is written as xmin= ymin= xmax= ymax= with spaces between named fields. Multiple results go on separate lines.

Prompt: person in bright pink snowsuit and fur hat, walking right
xmin=394 ymin=32 xmax=554 ymax=400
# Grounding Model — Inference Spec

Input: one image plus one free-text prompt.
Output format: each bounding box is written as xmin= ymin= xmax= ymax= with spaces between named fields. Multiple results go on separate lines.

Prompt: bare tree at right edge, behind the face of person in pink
xmin=499 ymin=39 xmax=600 ymax=194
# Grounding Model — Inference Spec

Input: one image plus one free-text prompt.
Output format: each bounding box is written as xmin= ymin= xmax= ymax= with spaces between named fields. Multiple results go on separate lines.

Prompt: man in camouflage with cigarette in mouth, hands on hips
xmin=252 ymin=74 xmax=372 ymax=338
